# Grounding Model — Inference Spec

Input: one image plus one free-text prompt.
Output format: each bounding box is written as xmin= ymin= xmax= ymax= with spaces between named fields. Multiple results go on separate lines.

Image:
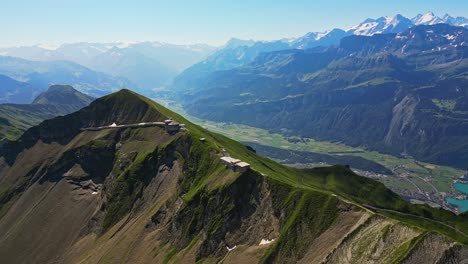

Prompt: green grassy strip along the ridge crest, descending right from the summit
xmin=129 ymin=89 xmax=468 ymax=245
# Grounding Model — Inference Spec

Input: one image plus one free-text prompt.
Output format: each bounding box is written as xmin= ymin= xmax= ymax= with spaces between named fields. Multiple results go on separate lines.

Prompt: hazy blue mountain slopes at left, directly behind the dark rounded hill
xmin=0 ymin=56 xmax=133 ymax=97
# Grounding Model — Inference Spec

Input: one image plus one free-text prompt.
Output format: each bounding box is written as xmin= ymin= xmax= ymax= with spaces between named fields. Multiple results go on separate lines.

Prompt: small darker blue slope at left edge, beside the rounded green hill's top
xmin=0 ymin=75 xmax=39 ymax=104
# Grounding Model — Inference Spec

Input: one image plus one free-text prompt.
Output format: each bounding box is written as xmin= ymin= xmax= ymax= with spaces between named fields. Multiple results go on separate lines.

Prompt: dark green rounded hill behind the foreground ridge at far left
xmin=0 ymin=85 xmax=93 ymax=140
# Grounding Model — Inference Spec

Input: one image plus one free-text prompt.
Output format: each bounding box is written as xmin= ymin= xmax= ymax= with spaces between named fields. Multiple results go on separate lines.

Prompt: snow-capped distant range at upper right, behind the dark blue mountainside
xmin=174 ymin=12 xmax=468 ymax=89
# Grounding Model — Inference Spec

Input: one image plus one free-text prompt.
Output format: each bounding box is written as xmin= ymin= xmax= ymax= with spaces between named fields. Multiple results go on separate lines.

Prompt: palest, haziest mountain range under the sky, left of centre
xmin=0 ymin=42 xmax=216 ymax=90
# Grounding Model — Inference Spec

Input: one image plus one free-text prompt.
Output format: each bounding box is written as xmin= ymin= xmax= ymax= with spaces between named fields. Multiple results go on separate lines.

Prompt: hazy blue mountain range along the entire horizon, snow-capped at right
xmin=0 ymin=12 xmax=468 ymax=98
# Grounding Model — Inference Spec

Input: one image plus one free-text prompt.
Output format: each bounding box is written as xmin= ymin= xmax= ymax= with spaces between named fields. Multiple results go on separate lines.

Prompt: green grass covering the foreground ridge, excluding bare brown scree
xmin=0 ymin=90 xmax=468 ymax=263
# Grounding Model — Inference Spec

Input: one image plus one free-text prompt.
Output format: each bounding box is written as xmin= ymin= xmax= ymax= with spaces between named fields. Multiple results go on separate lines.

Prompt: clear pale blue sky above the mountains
xmin=0 ymin=0 xmax=468 ymax=47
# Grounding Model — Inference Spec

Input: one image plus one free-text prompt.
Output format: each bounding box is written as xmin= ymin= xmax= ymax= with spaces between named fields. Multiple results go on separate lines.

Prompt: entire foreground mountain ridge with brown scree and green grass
xmin=0 ymin=90 xmax=468 ymax=263
